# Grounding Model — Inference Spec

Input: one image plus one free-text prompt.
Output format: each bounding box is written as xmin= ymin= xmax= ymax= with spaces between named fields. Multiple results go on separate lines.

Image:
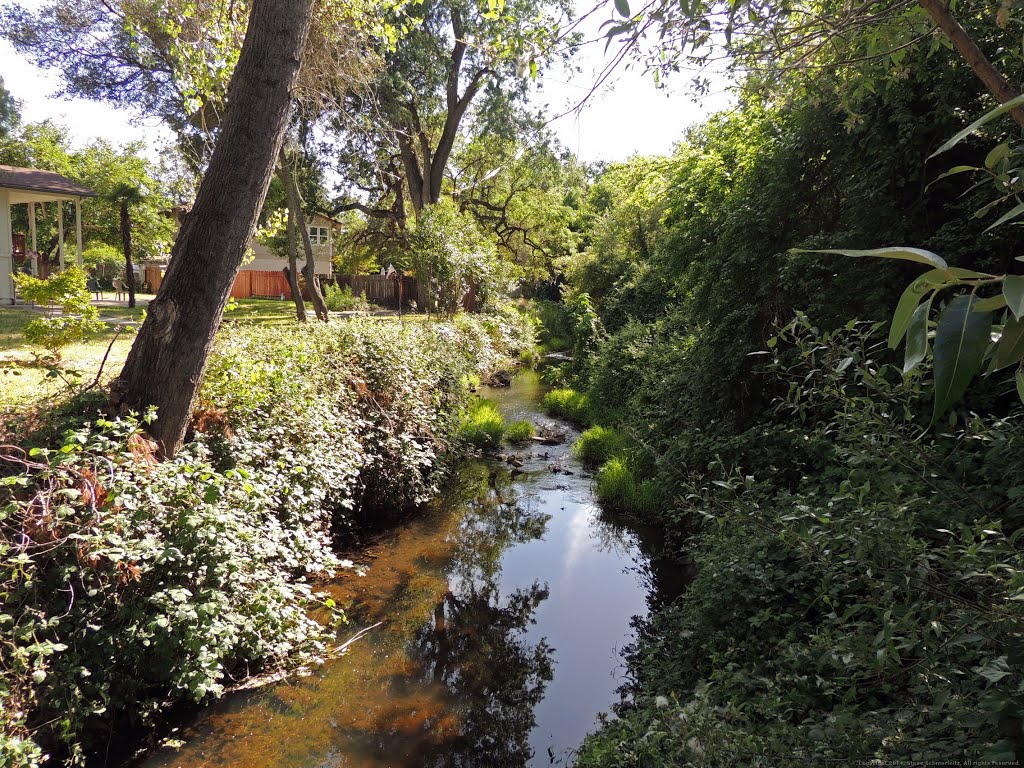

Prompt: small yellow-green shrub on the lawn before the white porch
xmin=13 ymin=264 xmax=103 ymax=359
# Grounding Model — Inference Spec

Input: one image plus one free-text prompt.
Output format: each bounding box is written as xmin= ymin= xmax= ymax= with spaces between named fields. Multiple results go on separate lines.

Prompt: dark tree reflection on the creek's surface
xmin=411 ymin=466 xmax=553 ymax=768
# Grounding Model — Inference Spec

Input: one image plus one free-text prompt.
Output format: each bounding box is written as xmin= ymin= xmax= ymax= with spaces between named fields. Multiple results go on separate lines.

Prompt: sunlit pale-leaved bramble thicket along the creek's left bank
xmin=0 ymin=311 xmax=532 ymax=765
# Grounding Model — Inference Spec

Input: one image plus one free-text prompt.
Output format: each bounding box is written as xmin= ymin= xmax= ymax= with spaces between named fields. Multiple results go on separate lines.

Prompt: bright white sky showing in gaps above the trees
xmin=0 ymin=0 xmax=729 ymax=162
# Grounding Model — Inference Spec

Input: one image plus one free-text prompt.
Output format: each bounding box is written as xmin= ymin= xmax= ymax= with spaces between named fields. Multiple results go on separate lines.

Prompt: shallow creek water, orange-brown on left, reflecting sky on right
xmin=144 ymin=374 xmax=649 ymax=768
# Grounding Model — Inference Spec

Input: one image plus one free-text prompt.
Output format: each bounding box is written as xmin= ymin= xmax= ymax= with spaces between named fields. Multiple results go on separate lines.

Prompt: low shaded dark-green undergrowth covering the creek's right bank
xmin=578 ymin=319 xmax=1024 ymax=768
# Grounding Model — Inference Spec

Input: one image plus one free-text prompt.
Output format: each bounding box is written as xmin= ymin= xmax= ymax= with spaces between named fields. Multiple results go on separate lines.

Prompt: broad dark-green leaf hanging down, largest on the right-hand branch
xmin=932 ymin=296 xmax=992 ymax=424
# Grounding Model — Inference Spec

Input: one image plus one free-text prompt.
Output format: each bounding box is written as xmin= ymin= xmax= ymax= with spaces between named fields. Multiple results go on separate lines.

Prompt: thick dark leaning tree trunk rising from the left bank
xmin=111 ymin=0 xmax=312 ymax=456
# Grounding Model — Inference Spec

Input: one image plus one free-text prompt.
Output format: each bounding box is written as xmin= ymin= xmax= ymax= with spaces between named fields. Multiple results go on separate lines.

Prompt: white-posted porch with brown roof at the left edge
xmin=0 ymin=165 xmax=96 ymax=305
